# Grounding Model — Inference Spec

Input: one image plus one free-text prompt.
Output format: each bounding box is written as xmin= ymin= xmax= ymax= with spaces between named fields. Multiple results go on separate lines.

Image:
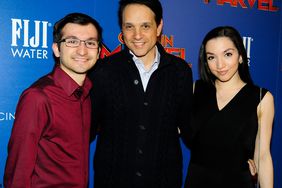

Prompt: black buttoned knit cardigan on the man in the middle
xmin=90 ymin=44 xmax=192 ymax=188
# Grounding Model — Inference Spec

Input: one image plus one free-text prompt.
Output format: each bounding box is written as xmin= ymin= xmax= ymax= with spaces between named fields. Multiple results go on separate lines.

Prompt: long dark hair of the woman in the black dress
xmin=199 ymin=26 xmax=253 ymax=84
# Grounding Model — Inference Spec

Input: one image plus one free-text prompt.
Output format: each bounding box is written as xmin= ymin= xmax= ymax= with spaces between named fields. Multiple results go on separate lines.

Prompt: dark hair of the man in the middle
xmin=118 ymin=0 xmax=163 ymax=28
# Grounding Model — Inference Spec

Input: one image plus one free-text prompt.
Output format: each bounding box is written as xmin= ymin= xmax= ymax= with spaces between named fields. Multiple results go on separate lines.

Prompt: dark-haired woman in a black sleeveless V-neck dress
xmin=185 ymin=26 xmax=274 ymax=188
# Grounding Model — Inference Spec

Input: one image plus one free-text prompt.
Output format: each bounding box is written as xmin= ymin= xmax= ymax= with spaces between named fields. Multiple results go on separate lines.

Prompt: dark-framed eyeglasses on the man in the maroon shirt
xmin=59 ymin=38 xmax=99 ymax=49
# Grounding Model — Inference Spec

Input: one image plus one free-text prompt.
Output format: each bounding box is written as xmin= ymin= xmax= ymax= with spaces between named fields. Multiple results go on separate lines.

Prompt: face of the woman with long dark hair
xmin=206 ymin=37 xmax=242 ymax=82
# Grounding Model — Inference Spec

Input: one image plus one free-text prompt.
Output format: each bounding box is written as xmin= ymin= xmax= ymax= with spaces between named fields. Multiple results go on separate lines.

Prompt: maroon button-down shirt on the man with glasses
xmin=4 ymin=67 xmax=92 ymax=188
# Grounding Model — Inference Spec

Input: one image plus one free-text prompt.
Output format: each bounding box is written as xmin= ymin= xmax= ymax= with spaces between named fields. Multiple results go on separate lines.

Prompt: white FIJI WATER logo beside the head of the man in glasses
xmin=11 ymin=18 xmax=51 ymax=59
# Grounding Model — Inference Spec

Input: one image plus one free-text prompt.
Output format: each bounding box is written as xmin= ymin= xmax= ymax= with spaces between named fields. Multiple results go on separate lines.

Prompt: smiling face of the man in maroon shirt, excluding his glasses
xmin=52 ymin=23 xmax=99 ymax=83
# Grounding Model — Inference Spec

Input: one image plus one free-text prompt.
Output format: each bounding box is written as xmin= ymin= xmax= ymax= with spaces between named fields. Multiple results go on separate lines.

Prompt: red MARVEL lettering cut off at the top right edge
xmin=204 ymin=0 xmax=279 ymax=12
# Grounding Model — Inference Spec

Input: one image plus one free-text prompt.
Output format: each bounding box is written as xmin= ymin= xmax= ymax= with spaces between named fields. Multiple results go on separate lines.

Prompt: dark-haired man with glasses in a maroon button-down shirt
xmin=4 ymin=13 xmax=102 ymax=188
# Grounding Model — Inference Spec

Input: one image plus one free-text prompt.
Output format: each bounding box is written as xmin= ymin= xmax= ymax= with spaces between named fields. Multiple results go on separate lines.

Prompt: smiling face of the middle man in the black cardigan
xmin=122 ymin=4 xmax=163 ymax=62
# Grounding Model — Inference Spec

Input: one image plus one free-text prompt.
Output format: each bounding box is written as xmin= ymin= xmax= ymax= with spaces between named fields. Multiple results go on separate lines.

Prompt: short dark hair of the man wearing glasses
xmin=53 ymin=13 xmax=102 ymax=45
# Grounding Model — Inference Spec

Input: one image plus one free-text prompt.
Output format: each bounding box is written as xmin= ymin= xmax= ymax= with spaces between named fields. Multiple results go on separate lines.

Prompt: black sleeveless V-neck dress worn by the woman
xmin=185 ymin=81 xmax=267 ymax=188
